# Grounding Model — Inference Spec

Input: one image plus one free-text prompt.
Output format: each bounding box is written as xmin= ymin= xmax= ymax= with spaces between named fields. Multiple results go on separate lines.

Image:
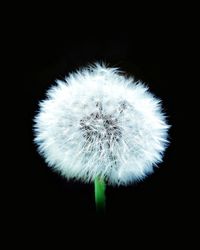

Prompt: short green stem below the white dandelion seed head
xmin=94 ymin=177 xmax=106 ymax=213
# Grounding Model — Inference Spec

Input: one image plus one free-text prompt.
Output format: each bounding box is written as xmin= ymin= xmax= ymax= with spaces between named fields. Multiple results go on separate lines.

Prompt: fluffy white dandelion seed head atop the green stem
xmin=34 ymin=64 xmax=169 ymax=185
